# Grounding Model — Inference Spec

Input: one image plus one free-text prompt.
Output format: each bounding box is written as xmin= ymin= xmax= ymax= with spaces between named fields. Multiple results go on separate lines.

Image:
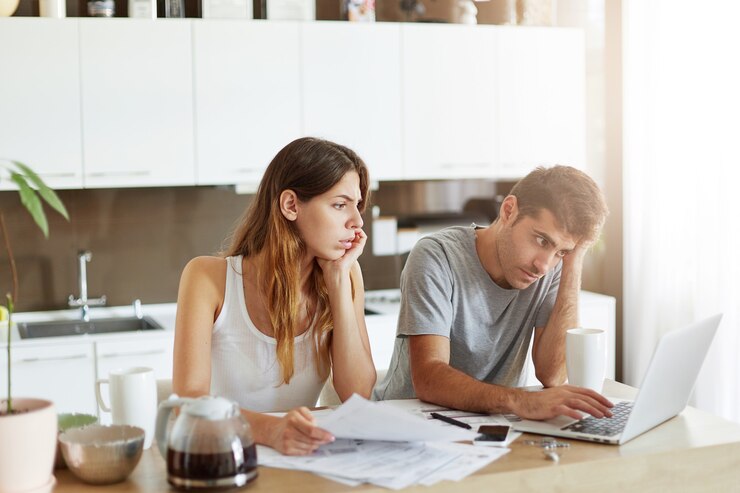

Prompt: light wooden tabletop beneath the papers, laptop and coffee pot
xmin=54 ymin=382 xmax=740 ymax=493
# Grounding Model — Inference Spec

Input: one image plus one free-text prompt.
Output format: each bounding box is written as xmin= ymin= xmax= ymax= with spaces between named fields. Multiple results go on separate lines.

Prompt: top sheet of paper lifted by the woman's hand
xmin=316 ymin=394 xmax=478 ymax=442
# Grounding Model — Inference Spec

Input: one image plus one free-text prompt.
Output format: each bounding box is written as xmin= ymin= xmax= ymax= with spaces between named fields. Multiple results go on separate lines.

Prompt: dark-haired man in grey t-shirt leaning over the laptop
xmin=373 ymin=166 xmax=611 ymax=419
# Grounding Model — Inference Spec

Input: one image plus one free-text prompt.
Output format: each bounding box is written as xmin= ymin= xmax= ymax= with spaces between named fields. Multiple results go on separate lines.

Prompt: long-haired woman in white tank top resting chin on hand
xmin=173 ymin=138 xmax=376 ymax=455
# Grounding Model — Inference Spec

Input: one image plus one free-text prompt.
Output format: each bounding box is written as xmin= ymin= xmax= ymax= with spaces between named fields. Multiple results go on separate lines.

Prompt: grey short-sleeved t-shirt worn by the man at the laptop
xmin=373 ymin=225 xmax=562 ymax=400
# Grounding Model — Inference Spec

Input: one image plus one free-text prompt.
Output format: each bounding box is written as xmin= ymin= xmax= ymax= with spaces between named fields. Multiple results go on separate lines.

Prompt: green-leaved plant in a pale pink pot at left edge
xmin=0 ymin=160 xmax=69 ymax=492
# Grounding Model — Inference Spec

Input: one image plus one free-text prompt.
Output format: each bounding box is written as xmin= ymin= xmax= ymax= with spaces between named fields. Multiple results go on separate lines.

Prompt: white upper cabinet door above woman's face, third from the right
xmin=302 ymin=22 xmax=403 ymax=181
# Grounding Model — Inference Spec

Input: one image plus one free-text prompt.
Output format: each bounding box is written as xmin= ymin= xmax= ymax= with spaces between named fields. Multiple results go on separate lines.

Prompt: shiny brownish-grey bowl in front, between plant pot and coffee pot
xmin=59 ymin=425 xmax=144 ymax=484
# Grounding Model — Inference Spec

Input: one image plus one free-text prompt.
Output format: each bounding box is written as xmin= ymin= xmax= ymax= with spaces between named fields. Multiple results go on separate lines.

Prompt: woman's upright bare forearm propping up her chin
xmin=322 ymin=262 xmax=377 ymax=401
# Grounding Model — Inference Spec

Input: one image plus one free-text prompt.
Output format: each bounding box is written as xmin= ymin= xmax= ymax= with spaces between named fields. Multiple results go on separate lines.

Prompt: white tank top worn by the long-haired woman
xmin=211 ymin=255 xmax=325 ymax=412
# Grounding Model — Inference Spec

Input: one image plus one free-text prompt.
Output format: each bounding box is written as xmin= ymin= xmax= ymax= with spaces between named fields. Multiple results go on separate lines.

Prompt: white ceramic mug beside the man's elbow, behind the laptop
xmin=565 ymin=328 xmax=606 ymax=393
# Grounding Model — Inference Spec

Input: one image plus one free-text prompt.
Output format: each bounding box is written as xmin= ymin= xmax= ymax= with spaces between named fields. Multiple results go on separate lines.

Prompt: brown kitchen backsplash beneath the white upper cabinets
xmin=0 ymin=180 xmax=506 ymax=311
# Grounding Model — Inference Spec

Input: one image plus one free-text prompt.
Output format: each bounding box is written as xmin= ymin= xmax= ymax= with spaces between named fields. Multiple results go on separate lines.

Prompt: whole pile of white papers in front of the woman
xmin=257 ymin=396 xmax=509 ymax=489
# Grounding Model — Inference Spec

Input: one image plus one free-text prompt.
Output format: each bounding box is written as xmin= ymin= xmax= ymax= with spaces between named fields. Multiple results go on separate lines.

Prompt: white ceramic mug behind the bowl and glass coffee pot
xmin=95 ymin=367 xmax=157 ymax=449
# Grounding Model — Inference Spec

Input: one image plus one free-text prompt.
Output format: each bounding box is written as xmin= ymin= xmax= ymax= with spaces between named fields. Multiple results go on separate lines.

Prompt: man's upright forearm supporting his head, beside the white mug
xmin=532 ymin=244 xmax=587 ymax=387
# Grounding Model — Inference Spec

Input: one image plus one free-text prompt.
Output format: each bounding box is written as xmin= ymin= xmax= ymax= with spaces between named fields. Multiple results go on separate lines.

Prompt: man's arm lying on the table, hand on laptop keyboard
xmin=408 ymin=335 xmax=611 ymax=419
